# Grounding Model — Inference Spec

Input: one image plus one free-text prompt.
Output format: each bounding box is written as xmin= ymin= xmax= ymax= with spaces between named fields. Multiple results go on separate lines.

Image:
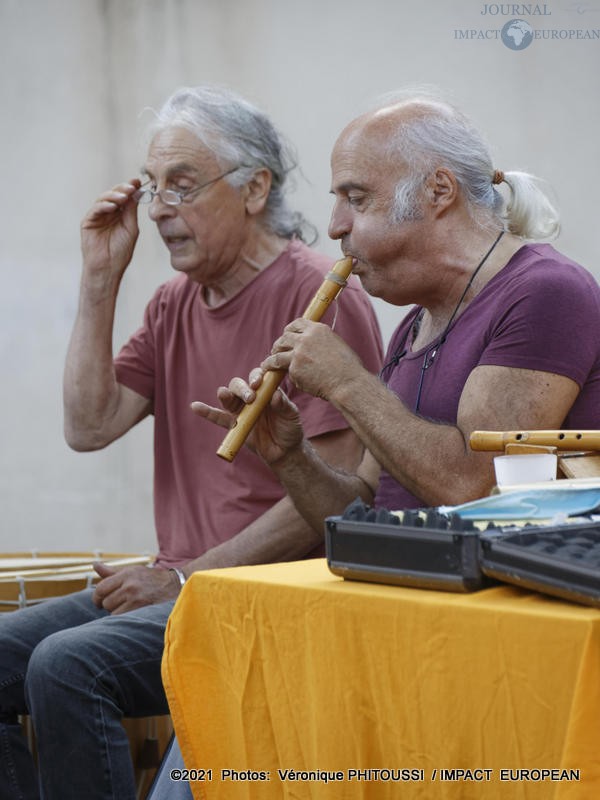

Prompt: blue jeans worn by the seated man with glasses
xmin=0 ymin=590 xmax=174 ymax=800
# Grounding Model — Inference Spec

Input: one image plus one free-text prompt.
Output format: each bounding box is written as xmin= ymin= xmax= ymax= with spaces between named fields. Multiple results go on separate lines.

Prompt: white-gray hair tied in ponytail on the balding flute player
xmin=390 ymin=100 xmax=560 ymax=239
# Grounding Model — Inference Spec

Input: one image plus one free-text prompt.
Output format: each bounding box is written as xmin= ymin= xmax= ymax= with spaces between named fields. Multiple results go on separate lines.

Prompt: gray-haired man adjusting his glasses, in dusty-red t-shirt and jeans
xmin=0 ymin=88 xmax=381 ymax=800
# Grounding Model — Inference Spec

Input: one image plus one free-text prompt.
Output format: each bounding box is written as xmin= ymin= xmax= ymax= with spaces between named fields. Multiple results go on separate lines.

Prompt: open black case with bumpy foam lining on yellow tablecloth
xmin=325 ymin=498 xmax=600 ymax=608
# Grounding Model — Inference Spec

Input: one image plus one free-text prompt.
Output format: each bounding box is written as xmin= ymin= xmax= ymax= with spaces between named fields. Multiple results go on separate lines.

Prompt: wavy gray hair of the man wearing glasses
xmin=150 ymin=86 xmax=316 ymax=241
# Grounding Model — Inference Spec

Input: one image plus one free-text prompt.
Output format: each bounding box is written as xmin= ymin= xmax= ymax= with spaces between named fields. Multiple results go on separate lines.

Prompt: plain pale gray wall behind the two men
xmin=0 ymin=0 xmax=600 ymax=552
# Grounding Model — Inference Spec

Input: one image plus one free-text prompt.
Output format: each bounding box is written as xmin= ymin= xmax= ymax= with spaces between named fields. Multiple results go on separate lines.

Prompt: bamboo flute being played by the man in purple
xmin=217 ymin=258 xmax=352 ymax=461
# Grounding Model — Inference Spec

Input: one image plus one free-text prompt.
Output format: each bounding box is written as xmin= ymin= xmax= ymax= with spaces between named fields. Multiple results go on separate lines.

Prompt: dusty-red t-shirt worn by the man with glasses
xmin=115 ymin=241 xmax=382 ymax=566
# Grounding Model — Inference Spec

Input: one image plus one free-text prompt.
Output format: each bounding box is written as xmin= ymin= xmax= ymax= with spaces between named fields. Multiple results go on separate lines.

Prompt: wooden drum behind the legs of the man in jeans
xmin=0 ymin=550 xmax=173 ymax=798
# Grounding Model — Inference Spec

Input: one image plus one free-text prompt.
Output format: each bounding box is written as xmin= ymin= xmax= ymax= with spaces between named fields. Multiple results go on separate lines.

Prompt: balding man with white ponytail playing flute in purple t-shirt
xmin=194 ymin=89 xmax=600 ymax=531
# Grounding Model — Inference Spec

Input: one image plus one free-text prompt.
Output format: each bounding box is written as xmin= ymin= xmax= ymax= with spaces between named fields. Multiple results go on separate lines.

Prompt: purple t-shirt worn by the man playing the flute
xmin=375 ymin=244 xmax=600 ymax=510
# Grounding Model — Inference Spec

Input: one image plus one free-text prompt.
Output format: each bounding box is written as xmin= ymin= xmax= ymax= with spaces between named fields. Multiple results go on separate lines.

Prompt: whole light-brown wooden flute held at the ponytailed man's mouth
xmin=217 ymin=258 xmax=352 ymax=461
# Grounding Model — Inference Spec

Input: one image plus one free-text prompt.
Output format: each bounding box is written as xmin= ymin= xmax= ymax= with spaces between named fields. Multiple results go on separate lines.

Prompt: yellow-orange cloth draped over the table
xmin=163 ymin=560 xmax=600 ymax=800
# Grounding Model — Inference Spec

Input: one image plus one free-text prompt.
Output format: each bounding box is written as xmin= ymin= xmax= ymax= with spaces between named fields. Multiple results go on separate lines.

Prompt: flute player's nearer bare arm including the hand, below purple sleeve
xmin=261 ymin=320 xmax=579 ymax=506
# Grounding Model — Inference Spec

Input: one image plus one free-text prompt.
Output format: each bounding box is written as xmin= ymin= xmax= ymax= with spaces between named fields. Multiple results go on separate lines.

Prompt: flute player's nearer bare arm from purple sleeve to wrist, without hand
xmin=329 ymin=366 xmax=578 ymax=506
